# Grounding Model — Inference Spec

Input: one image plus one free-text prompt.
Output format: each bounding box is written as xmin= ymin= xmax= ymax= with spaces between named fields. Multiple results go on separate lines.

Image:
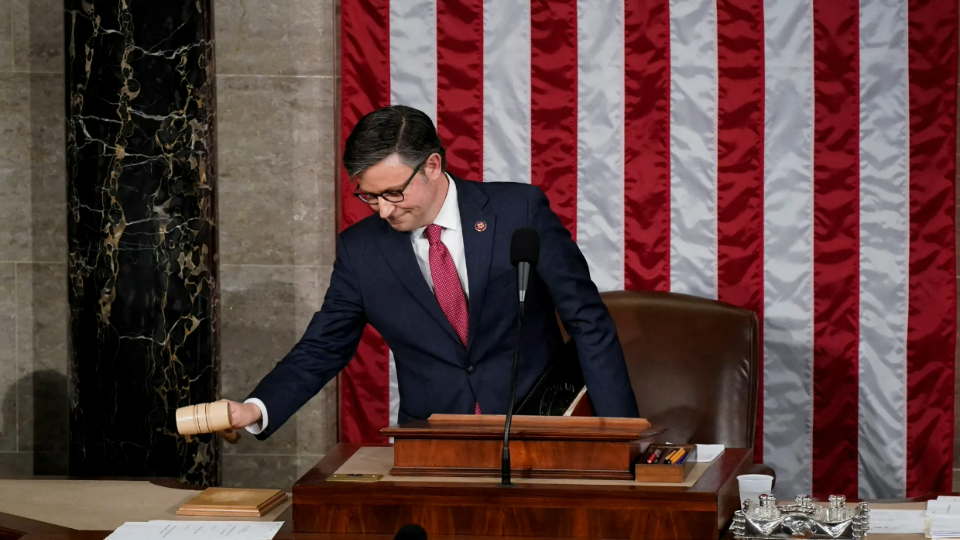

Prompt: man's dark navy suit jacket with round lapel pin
xmin=249 ymin=175 xmax=639 ymax=440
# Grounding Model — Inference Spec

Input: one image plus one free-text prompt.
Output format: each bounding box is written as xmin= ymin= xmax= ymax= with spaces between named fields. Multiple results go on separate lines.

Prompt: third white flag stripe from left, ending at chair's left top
xmin=577 ymin=0 xmax=625 ymax=291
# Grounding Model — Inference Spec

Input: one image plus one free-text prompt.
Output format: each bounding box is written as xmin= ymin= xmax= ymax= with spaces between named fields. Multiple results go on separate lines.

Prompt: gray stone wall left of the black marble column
xmin=0 ymin=0 xmax=68 ymax=476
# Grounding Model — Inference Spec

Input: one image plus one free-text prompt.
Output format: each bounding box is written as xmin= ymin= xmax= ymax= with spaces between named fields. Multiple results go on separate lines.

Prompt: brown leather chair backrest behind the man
xmin=601 ymin=291 xmax=760 ymax=448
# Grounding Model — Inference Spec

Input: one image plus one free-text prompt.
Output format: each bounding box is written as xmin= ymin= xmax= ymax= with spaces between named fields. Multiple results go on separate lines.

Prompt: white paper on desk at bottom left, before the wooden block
xmin=105 ymin=520 xmax=283 ymax=540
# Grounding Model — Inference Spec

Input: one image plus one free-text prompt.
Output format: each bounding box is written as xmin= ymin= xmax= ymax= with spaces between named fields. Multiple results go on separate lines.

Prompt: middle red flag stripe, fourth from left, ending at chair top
xmin=623 ymin=0 xmax=670 ymax=291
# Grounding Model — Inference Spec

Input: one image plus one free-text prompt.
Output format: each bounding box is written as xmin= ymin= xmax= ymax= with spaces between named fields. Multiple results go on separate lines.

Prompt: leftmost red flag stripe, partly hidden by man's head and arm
xmin=339 ymin=0 xmax=390 ymax=443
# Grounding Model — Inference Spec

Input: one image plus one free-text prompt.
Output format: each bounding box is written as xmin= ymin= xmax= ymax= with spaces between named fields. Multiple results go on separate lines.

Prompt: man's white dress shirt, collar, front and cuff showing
xmin=244 ymin=174 xmax=470 ymax=435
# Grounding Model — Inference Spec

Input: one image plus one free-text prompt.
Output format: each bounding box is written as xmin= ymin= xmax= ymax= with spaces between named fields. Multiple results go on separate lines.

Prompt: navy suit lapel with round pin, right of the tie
xmin=451 ymin=175 xmax=497 ymax=348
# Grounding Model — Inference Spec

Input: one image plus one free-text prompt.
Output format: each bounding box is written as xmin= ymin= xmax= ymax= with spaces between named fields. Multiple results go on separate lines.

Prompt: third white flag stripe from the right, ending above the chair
xmin=670 ymin=0 xmax=718 ymax=298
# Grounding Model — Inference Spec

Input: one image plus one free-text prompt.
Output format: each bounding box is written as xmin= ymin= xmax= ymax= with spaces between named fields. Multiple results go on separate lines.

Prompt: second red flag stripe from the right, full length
xmin=813 ymin=0 xmax=860 ymax=497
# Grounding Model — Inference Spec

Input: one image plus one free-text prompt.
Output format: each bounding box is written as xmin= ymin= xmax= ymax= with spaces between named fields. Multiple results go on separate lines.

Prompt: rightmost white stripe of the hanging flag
xmin=858 ymin=0 xmax=910 ymax=498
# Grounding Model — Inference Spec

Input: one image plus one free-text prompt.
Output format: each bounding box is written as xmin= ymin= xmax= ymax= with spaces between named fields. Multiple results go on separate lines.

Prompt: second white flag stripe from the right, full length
xmin=763 ymin=0 xmax=813 ymax=496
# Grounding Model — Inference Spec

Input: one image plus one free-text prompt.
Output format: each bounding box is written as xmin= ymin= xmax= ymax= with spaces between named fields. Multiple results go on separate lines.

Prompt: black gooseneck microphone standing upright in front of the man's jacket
xmin=500 ymin=227 xmax=540 ymax=486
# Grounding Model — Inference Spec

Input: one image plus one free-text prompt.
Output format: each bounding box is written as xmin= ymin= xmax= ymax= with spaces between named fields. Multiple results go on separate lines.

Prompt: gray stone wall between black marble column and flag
xmin=214 ymin=0 xmax=338 ymax=487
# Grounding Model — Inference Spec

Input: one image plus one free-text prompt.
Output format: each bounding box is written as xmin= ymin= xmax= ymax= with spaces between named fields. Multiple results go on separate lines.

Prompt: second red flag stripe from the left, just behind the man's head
xmin=437 ymin=0 xmax=483 ymax=181
